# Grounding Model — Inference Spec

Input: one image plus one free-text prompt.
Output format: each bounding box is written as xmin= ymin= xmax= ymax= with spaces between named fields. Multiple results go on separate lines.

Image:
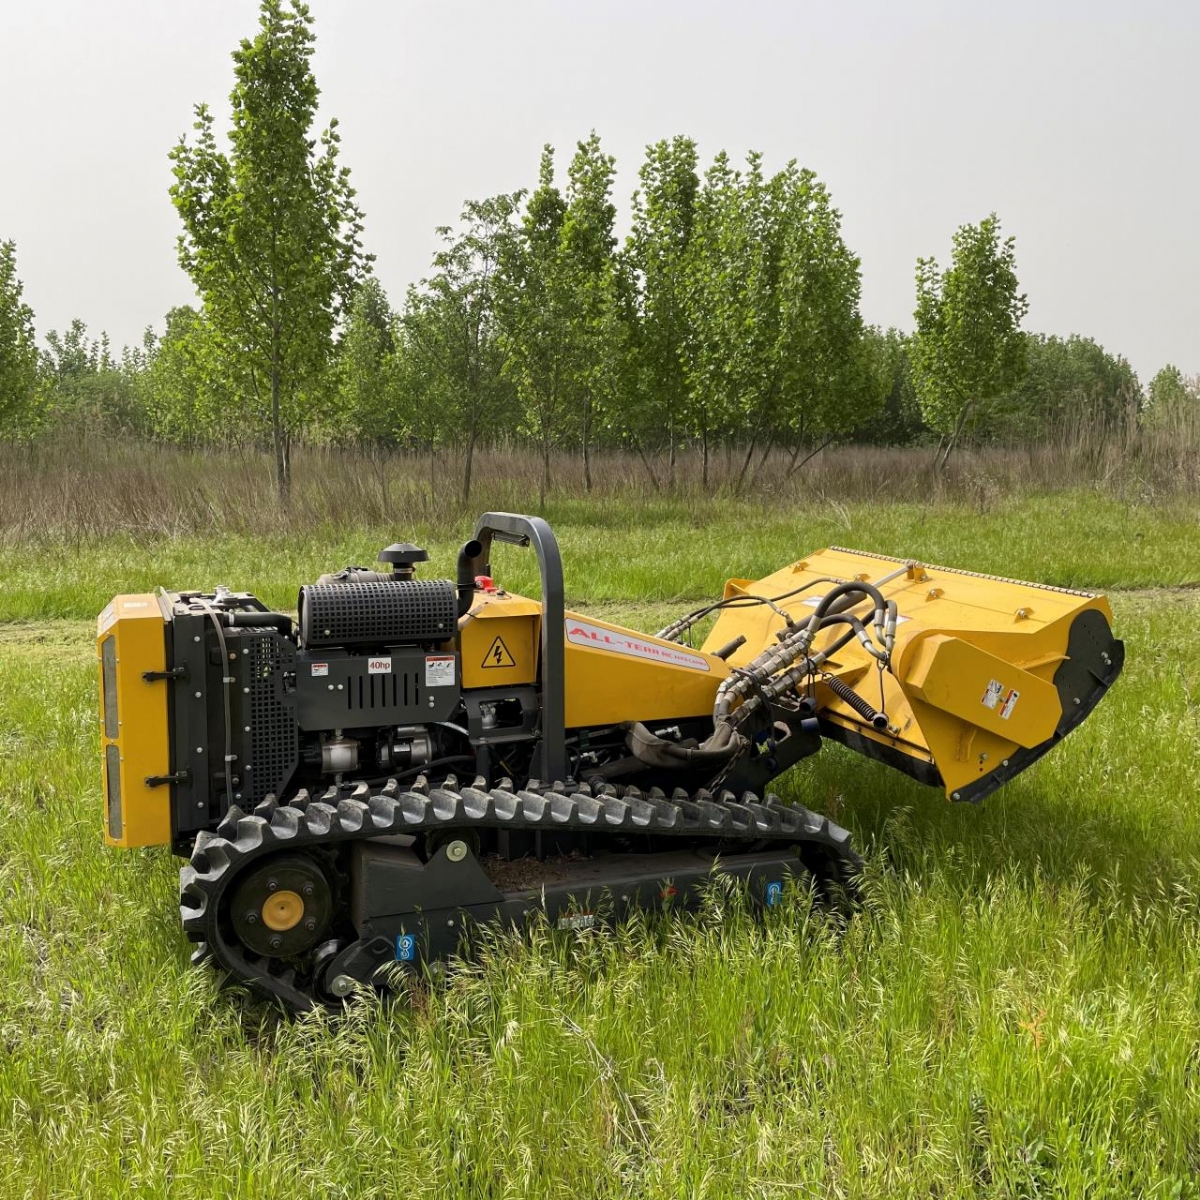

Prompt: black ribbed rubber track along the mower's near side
xmin=179 ymin=775 xmax=862 ymax=1009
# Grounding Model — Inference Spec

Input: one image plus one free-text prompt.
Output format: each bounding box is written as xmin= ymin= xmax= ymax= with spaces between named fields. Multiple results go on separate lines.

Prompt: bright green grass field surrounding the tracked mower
xmin=0 ymin=493 xmax=1200 ymax=1200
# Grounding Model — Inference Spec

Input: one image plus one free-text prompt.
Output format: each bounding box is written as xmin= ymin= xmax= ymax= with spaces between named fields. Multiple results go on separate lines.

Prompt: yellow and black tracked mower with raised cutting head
xmin=97 ymin=512 xmax=1123 ymax=1009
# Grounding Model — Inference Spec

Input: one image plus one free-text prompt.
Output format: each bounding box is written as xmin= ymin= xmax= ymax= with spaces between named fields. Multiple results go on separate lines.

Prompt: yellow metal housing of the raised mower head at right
xmin=703 ymin=547 xmax=1112 ymax=796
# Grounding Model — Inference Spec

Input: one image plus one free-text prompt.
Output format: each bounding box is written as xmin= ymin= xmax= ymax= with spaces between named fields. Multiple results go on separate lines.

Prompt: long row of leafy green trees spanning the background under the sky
xmin=0 ymin=0 xmax=1200 ymax=502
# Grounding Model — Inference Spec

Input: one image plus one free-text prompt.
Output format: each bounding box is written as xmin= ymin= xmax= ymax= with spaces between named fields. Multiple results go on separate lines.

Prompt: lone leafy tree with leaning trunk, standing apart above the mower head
xmin=910 ymin=212 xmax=1028 ymax=468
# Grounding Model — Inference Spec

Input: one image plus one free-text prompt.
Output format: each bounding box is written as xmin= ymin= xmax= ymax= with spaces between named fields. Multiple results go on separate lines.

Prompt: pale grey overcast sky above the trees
xmin=0 ymin=0 xmax=1200 ymax=382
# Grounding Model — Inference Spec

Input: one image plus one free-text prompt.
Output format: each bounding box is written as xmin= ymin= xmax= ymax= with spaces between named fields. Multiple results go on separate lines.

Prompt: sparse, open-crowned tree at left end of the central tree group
xmin=404 ymin=192 xmax=523 ymax=504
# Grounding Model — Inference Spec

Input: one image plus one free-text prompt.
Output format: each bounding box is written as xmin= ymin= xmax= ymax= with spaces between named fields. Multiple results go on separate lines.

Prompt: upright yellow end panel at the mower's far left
xmin=96 ymin=593 xmax=170 ymax=846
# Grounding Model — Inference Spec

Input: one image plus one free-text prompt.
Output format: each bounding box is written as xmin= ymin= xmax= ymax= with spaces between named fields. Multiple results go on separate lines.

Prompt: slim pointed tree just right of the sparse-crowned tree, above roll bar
xmin=497 ymin=145 xmax=570 ymax=508
